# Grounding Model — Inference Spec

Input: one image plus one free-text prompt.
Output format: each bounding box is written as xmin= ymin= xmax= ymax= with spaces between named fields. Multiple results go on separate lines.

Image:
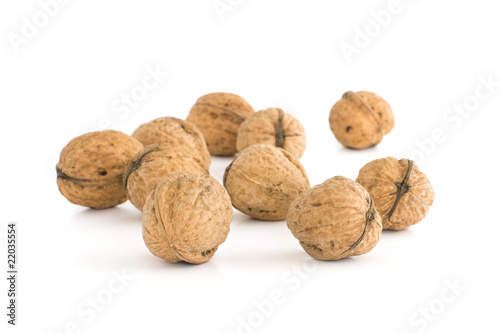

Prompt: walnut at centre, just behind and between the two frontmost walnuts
xmin=224 ymin=145 xmax=310 ymax=221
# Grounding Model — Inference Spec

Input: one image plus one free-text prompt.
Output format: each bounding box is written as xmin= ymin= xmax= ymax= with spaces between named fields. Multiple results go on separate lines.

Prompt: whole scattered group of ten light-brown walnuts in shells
xmin=56 ymin=91 xmax=434 ymax=264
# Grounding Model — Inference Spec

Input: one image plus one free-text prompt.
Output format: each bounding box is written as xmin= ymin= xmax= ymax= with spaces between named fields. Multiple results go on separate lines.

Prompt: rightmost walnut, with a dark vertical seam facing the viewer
xmin=356 ymin=157 xmax=434 ymax=230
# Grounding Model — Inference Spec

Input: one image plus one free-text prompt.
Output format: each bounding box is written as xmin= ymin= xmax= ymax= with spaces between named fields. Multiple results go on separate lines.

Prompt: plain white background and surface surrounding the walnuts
xmin=0 ymin=0 xmax=500 ymax=333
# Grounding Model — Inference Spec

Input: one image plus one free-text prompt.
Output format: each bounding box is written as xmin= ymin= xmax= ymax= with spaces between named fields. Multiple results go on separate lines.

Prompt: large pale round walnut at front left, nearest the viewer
xmin=142 ymin=173 xmax=233 ymax=264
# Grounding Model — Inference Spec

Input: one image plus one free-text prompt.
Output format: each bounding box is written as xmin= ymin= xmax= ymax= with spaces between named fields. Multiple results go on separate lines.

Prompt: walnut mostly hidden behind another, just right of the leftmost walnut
xmin=132 ymin=117 xmax=210 ymax=169
